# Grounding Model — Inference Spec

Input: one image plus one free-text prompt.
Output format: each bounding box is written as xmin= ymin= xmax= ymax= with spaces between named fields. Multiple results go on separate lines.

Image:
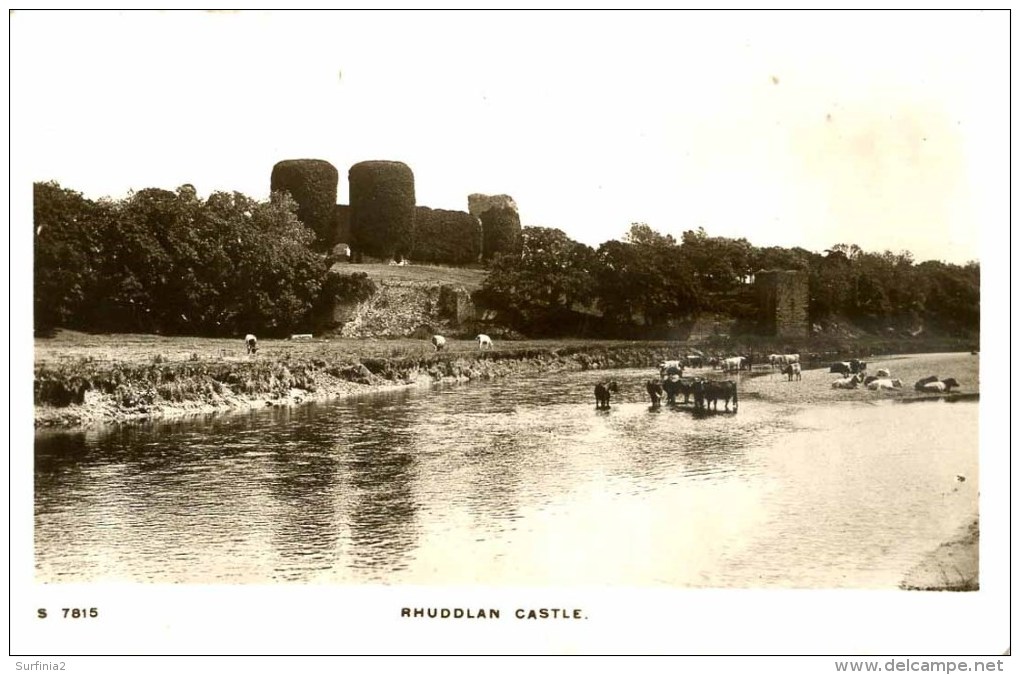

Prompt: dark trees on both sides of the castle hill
xmin=34 ymin=183 xmax=980 ymax=338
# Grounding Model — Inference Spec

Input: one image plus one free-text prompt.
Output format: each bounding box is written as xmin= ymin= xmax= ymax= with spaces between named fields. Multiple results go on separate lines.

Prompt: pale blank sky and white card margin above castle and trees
xmin=10 ymin=11 xmax=1010 ymax=263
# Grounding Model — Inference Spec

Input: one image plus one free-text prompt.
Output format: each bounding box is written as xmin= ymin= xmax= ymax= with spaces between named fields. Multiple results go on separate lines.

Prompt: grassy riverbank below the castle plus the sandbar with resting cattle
xmin=34 ymin=331 xmax=977 ymax=427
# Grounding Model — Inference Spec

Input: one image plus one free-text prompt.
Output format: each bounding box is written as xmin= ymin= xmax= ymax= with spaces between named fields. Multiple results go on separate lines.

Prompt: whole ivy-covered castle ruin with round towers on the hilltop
xmin=270 ymin=159 xmax=520 ymax=264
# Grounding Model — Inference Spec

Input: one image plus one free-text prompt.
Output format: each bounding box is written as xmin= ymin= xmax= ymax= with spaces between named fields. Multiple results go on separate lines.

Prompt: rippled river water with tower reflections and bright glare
xmin=35 ymin=370 xmax=977 ymax=587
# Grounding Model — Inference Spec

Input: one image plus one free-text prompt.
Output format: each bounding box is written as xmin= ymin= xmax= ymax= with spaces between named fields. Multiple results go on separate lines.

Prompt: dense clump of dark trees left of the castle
xmin=34 ymin=183 xmax=326 ymax=334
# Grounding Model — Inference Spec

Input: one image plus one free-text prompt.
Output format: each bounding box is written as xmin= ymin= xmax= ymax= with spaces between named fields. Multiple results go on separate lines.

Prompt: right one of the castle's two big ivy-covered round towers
xmin=348 ymin=161 xmax=415 ymax=260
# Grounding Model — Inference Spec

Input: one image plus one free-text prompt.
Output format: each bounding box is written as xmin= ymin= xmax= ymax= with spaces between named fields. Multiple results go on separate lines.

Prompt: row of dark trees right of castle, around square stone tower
xmin=478 ymin=223 xmax=980 ymax=336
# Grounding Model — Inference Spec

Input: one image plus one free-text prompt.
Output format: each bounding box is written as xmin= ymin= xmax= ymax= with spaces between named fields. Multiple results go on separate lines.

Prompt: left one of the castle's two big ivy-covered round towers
xmin=269 ymin=159 xmax=340 ymax=251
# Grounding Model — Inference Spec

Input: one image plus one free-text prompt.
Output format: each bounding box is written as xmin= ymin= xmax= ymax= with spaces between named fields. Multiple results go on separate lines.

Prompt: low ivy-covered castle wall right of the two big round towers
xmin=411 ymin=206 xmax=481 ymax=265
